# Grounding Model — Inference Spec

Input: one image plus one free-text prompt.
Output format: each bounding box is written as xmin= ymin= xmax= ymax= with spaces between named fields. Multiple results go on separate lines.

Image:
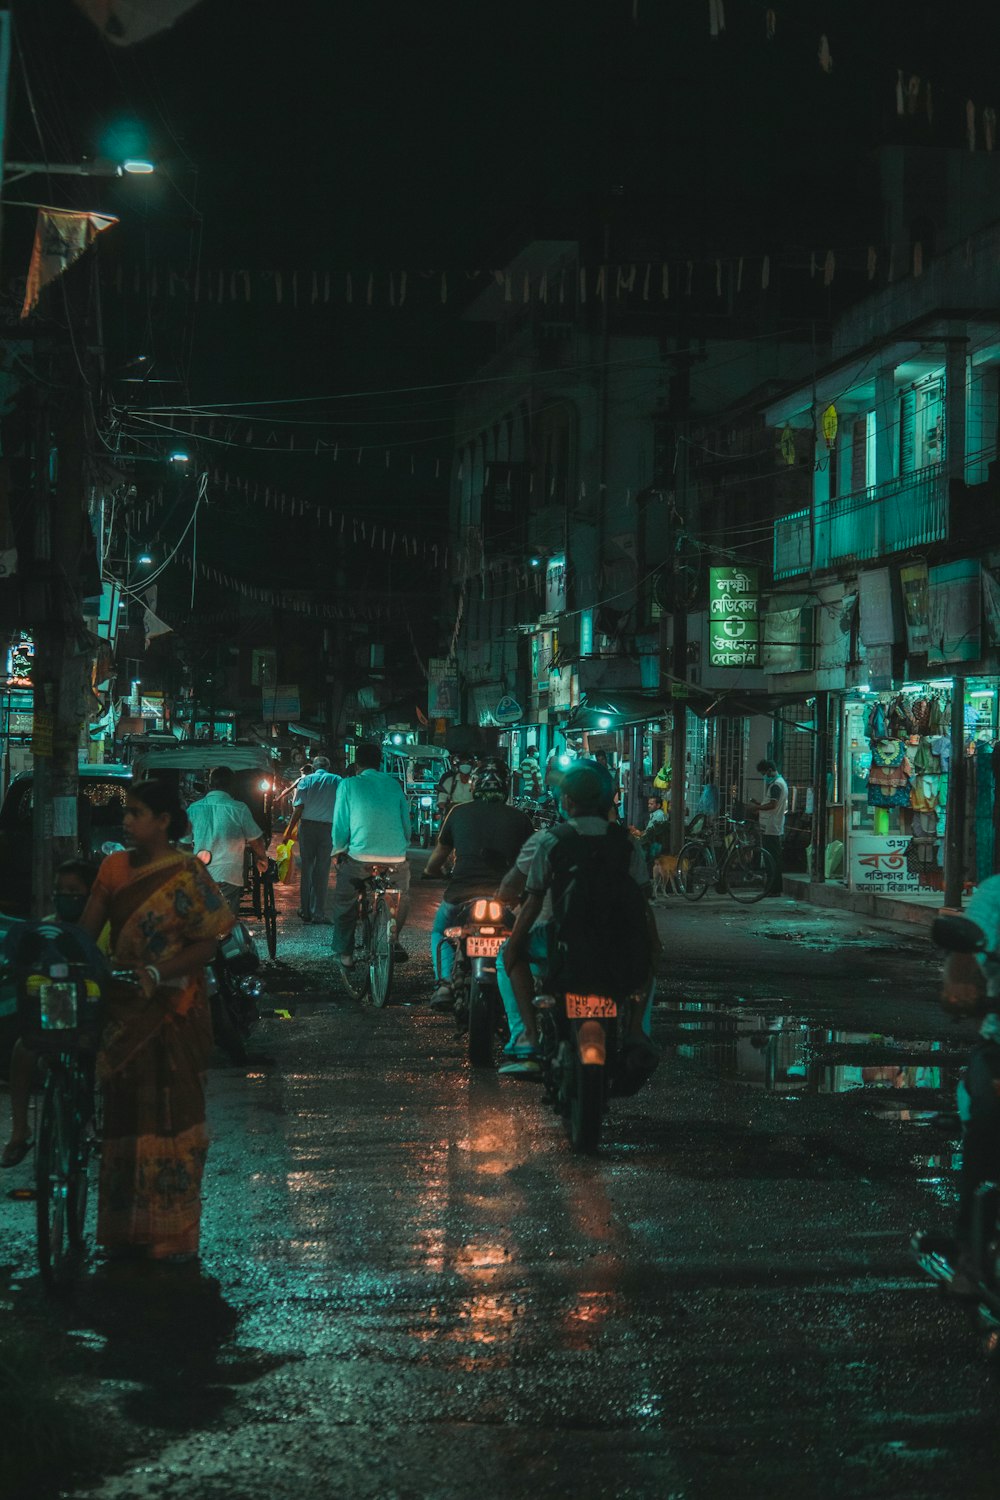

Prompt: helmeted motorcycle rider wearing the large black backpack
xmin=496 ymin=761 xmax=661 ymax=1074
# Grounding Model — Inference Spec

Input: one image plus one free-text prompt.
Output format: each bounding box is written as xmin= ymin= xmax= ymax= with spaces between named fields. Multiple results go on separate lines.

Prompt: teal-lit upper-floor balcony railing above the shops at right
xmin=774 ymin=464 xmax=948 ymax=578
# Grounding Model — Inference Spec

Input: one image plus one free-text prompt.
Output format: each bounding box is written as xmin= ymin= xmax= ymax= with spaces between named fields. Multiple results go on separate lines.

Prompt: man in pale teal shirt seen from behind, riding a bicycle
xmin=333 ymin=744 xmax=409 ymax=969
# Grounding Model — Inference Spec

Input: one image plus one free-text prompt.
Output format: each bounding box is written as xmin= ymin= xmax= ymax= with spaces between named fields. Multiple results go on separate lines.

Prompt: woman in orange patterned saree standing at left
xmin=81 ymin=782 xmax=234 ymax=1262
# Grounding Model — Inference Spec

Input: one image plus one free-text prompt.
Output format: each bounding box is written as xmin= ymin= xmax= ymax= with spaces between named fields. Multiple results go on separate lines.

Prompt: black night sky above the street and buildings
xmin=11 ymin=0 xmax=1000 ymax=609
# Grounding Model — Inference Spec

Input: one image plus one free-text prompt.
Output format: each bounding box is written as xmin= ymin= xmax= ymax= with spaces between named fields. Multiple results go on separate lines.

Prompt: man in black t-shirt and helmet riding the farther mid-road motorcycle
xmin=423 ymin=759 xmax=532 ymax=1011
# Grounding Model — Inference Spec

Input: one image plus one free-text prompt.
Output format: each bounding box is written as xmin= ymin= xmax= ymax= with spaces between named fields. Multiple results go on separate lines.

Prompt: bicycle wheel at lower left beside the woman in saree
xmin=34 ymin=1070 xmax=87 ymax=1292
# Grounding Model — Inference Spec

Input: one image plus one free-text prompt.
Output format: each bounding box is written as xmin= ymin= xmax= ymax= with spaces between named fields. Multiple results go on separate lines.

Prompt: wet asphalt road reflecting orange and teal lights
xmin=0 ymin=887 xmax=1000 ymax=1500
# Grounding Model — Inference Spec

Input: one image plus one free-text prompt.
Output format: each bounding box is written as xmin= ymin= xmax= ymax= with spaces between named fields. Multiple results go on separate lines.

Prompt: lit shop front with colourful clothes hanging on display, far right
xmin=829 ymin=678 xmax=999 ymax=905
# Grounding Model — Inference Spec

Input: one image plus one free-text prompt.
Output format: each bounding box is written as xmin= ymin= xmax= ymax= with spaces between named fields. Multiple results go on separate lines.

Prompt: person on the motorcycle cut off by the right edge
xmin=915 ymin=875 xmax=1000 ymax=1292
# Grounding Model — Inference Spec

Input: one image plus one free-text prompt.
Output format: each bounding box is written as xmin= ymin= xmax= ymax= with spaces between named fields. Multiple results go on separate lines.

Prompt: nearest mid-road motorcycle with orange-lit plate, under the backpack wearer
xmin=535 ymin=992 xmax=658 ymax=1155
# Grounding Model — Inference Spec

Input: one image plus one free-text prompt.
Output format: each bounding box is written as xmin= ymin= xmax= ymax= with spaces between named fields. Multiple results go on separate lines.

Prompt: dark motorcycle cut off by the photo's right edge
xmin=910 ymin=915 xmax=1000 ymax=1361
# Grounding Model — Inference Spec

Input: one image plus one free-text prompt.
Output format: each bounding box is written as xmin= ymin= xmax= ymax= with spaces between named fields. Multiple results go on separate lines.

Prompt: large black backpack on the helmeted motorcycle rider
xmin=549 ymin=824 xmax=651 ymax=996
